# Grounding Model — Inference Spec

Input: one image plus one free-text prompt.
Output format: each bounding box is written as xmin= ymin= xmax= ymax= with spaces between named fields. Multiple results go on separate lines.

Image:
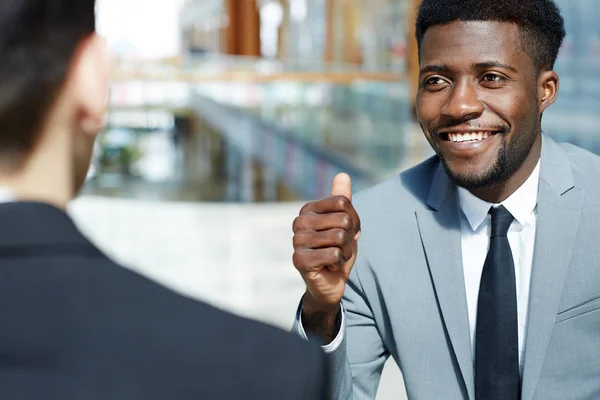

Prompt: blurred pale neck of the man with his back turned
xmin=0 ymin=127 xmax=74 ymax=210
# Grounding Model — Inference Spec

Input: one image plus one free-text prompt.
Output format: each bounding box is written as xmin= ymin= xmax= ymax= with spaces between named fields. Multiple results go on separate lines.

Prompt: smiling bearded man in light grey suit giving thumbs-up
xmin=294 ymin=0 xmax=600 ymax=400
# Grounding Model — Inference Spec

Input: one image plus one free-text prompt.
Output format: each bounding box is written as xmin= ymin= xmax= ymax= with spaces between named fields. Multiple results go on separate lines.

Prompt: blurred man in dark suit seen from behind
xmin=0 ymin=0 xmax=327 ymax=400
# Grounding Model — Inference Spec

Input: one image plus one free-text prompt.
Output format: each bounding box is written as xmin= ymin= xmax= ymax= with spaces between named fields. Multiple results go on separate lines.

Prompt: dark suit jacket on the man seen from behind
xmin=0 ymin=203 xmax=327 ymax=400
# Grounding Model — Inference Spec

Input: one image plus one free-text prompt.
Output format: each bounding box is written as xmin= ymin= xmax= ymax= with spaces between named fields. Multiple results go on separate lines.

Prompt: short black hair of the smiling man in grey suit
xmin=416 ymin=0 xmax=566 ymax=71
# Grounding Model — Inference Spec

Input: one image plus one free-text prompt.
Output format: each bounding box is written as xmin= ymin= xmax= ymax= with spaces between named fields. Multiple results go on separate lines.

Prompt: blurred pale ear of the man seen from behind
xmin=69 ymin=33 xmax=111 ymax=136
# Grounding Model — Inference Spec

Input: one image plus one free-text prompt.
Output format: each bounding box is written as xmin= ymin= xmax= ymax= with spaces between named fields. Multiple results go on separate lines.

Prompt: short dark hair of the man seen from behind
xmin=0 ymin=0 xmax=96 ymax=161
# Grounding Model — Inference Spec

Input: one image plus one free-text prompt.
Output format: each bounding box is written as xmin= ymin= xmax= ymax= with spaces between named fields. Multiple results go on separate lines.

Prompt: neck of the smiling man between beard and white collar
xmin=470 ymin=134 xmax=542 ymax=204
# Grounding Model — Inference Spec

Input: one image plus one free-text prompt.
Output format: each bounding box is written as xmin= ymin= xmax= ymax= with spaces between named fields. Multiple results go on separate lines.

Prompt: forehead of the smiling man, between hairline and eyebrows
xmin=420 ymin=21 xmax=529 ymax=66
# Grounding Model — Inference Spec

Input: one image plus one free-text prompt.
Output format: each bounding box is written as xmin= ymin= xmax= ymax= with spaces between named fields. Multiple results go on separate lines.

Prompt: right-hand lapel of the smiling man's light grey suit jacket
xmin=522 ymin=136 xmax=584 ymax=400
